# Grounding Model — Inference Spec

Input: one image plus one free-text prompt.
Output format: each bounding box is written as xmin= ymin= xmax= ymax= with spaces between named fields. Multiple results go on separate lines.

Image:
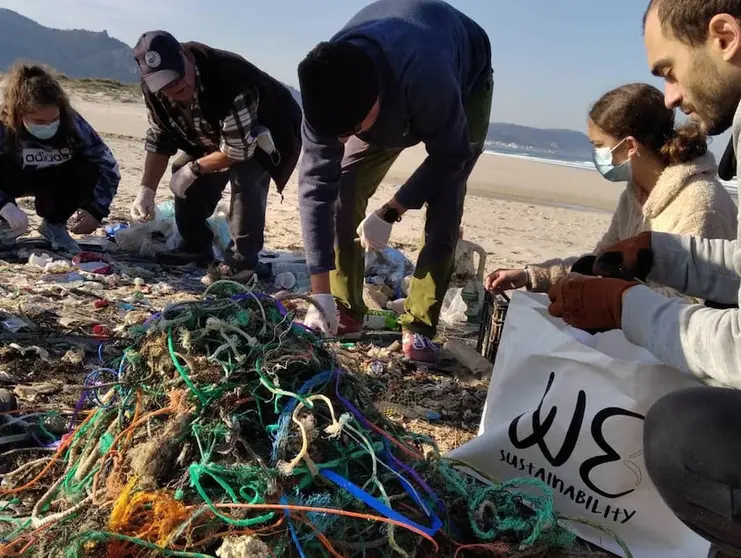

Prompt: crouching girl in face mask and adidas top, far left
xmin=0 ymin=64 xmax=121 ymax=253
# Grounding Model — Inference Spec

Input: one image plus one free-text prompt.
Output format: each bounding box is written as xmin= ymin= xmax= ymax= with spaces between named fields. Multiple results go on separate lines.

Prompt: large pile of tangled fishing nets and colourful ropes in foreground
xmin=0 ymin=283 xmax=608 ymax=558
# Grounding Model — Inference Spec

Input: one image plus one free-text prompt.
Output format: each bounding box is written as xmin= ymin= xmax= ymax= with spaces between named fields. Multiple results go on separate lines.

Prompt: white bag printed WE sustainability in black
xmin=450 ymin=292 xmax=709 ymax=558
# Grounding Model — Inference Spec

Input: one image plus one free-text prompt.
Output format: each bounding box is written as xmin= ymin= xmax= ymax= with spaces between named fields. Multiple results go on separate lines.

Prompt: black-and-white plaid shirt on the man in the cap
xmin=144 ymin=66 xmax=259 ymax=161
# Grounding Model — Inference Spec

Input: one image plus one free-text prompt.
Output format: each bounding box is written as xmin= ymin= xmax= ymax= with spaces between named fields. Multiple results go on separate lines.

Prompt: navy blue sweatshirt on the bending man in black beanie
xmin=299 ymin=0 xmax=491 ymax=273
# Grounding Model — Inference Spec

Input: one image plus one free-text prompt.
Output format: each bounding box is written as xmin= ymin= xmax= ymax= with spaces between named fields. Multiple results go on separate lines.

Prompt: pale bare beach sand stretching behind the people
xmin=73 ymin=94 xmax=621 ymax=271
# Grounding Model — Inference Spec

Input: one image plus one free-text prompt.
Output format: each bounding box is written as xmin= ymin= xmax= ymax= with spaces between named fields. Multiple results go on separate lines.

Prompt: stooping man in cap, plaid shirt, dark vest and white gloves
xmin=131 ymin=31 xmax=301 ymax=284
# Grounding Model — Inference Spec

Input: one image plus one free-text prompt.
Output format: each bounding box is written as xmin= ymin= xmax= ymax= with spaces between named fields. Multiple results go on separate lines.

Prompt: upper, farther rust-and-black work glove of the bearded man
xmin=593 ymin=232 xmax=654 ymax=281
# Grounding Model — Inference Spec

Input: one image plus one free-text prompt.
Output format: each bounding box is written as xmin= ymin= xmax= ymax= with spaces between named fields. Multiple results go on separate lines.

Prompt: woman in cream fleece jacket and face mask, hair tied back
xmin=486 ymin=83 xmax=737 ymax=296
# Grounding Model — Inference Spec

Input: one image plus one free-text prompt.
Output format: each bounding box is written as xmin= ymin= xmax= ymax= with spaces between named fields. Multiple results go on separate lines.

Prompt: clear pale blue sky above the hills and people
xmin=0 ymin=0 xmax=725 ymax=151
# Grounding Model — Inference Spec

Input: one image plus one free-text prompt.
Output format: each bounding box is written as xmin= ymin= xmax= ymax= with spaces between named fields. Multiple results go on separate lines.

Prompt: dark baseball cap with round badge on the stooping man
xmin=134 ymin=31 xmax=185 ymax=93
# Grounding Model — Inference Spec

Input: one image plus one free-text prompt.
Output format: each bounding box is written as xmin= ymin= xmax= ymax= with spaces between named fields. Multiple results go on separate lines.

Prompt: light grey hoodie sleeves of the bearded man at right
xmin=622 ymin=104 xmax=741 ymax=389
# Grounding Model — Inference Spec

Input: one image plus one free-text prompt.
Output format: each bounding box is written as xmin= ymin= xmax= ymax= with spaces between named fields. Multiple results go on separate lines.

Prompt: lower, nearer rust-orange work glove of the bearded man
xmin=548 ymin=276 xmax=640 ymax=331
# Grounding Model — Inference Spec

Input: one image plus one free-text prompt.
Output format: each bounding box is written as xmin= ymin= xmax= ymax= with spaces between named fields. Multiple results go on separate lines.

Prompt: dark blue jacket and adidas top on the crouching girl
xmin=0 ymin=112 xmax=121 ymax=219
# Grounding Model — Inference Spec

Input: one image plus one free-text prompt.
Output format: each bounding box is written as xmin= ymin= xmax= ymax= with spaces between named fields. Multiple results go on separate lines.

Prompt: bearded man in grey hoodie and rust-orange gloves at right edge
xmin=549 ymin=0 xmax=741 ymax=556
